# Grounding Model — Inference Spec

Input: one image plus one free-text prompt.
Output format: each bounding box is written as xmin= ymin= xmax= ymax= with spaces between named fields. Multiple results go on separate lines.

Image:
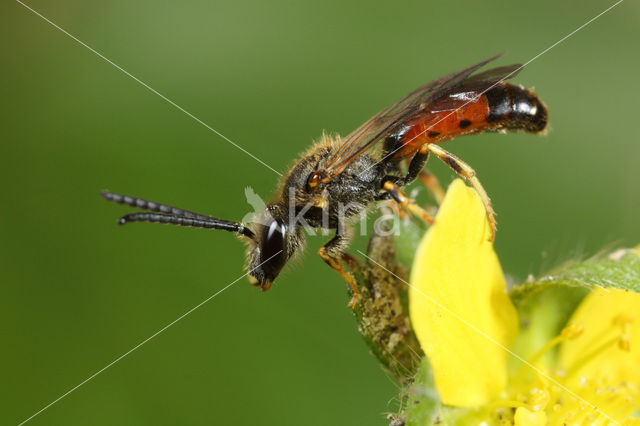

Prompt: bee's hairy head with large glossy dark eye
xmin=248 ymin=205 xmax=303 ymax=291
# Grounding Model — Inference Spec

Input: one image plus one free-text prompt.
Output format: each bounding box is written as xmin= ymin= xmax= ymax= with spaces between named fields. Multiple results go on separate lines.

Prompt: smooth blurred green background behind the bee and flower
xmin=0 ymin=0 xmax=640 ymax=425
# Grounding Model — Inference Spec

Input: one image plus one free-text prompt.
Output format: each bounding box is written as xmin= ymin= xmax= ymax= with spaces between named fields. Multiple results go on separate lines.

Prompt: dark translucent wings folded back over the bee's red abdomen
xmin=325 ymin=53 xmax=522 ymax=176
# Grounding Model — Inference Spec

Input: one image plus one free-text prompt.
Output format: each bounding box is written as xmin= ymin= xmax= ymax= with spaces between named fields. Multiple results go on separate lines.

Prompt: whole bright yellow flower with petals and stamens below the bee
xmin=409 ymin=180 xmax=640 ymax=426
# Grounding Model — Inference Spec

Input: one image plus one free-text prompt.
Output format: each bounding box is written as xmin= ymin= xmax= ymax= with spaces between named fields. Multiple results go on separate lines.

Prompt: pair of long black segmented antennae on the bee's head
xmin=100 ymin=191 xmax=255 ymax=240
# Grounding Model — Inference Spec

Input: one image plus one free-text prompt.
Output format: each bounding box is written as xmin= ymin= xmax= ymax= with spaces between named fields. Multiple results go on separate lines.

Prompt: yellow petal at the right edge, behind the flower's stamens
xmin=559 ymin=289 xmax=640 ymax=388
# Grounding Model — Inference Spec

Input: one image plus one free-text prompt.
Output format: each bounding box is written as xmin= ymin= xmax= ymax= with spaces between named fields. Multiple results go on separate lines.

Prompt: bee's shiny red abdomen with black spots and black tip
xmin=389 ymin=83 xmax=547 ymax=158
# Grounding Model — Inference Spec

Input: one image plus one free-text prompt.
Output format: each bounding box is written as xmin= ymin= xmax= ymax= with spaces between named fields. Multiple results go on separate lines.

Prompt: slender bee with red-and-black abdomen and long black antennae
xmin=102 ymin=54 xmax=548 ymax=307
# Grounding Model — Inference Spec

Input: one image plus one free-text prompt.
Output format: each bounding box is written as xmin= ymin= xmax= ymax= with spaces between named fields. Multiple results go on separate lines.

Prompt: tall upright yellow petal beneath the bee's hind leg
xmin=409 ymin=180 xmax=517 ymax=407
